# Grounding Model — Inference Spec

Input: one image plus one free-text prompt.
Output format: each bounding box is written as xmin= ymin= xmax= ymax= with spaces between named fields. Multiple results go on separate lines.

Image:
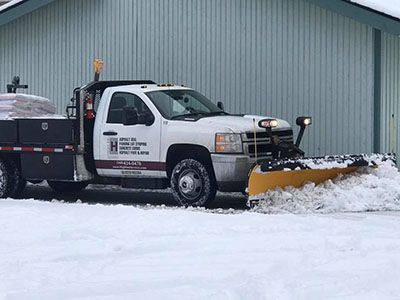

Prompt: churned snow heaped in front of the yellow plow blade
xmin=255 ymin=161 xmax=400 ymax=213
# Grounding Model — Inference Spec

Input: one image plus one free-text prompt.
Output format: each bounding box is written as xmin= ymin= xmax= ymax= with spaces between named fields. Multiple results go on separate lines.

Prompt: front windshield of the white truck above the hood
xmin=146 ymin=90 xmax=227 ymax=120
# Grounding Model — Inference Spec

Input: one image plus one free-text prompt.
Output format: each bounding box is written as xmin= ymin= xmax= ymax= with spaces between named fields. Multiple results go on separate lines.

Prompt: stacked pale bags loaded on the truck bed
xmin=0 ymin=94 xmax=56 ymax=119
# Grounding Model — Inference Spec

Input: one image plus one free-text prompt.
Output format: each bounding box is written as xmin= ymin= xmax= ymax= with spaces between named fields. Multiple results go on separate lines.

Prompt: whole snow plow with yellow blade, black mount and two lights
xmin=247 ymin=117 xmax=396 ymax=207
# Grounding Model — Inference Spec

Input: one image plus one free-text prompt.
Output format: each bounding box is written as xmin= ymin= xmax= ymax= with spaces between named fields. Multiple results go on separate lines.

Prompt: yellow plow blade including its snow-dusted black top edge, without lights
xmin=248 ymin=154 xmax=396 ymax=205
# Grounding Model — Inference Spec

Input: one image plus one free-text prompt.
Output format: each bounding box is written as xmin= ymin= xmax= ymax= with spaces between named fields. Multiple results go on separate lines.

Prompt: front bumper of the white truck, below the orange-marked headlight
xmin=211 ymin=154 xmax=255 ymax=192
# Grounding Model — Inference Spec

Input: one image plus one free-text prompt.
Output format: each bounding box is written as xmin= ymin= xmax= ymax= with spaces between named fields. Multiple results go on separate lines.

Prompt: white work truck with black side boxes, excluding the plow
xmin=0 ymin=81 xmax=293 ymax=206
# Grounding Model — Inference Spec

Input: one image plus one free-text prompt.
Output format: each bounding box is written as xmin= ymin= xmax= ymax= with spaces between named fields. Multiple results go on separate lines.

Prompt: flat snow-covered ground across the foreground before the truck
xmin=0 ymin=199 xmax=400 ymax=300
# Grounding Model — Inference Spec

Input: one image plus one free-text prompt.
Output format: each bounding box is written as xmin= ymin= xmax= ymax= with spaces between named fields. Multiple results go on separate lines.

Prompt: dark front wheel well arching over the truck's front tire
xmin=167 ymin=144 xmax=215 ymax=178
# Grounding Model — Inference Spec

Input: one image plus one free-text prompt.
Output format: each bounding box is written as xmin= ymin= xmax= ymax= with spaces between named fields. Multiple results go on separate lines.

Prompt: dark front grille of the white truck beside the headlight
xmin=242 ymin=129 xmax=293 ymax=157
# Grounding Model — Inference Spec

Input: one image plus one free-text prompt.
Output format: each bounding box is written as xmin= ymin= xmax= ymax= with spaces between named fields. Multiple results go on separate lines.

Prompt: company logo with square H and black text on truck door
xmin=107 ymin=137 xmax=150 ymax=156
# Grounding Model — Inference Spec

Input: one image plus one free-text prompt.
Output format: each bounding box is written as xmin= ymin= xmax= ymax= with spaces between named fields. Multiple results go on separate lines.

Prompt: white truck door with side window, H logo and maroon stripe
xmin=95 ymin=92 xmax=166 ymax=177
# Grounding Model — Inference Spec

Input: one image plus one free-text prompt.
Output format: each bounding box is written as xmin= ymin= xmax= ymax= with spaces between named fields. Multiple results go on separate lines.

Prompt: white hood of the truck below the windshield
xmin=196 ymin=115 xmax=291 ymax=133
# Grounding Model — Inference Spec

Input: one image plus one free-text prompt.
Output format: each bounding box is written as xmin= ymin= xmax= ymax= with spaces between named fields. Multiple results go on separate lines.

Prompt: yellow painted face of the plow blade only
xmin=248 ymin=165 xmax=359 ymax=197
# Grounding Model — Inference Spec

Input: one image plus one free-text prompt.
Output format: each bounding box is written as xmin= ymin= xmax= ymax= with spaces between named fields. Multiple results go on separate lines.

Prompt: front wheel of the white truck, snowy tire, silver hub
xmin=171 ymin=159 xmax=217 ymax=206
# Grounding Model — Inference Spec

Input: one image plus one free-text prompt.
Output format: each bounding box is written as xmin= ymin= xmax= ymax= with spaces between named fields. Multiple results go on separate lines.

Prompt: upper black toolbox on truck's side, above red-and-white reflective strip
xmin=17 ymin=119 xmax=74 ymax=144
